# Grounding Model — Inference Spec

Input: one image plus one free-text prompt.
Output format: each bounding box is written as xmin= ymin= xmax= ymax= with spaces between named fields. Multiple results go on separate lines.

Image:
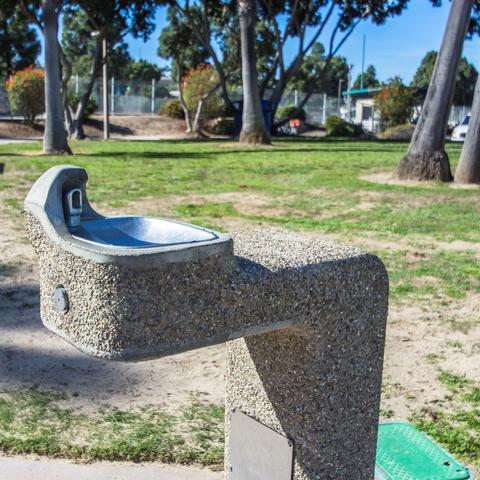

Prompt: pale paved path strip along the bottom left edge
xmin=0 ymin=457 xmax=223 ymax=480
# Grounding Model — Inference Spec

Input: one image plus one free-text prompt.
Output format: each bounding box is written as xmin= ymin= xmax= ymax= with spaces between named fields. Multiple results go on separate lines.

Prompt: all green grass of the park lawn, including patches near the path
xmin=0 ymin=139 xmax=480 ymax=465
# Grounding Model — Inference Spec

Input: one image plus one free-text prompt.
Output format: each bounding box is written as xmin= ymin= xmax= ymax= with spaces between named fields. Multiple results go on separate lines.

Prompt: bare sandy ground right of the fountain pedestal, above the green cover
xmin=382 ymin=295 xmax=480 ymax=418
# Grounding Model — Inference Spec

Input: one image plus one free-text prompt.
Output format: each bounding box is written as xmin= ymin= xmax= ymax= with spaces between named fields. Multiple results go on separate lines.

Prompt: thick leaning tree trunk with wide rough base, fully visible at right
xmin=398 ymin=0 xmax=473 ymax=182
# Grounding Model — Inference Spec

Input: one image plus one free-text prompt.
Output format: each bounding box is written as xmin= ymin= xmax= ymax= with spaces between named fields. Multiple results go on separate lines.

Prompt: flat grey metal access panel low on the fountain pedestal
xmin=228 ymin=410 xmax=293 ymax=480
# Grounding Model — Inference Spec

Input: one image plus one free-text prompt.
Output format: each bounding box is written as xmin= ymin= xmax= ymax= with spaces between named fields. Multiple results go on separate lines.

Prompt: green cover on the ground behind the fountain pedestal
xmin=376 ymin=422 xmax=470 ymax=480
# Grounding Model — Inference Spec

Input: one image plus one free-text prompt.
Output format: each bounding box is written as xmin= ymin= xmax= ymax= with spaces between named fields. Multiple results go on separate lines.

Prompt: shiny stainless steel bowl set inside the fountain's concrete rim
xmin=69 ymin=216 xmax=218 ymax=248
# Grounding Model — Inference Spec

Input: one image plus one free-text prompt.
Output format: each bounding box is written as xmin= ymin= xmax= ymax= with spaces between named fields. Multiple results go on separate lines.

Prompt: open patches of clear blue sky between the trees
xmin=122 ymin=0 xmax=480 ymax=82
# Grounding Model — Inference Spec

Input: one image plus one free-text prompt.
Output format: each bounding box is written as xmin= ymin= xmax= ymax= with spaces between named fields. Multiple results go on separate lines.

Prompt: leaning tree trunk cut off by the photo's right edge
xmin=455 ymin=76 xmax=480 ymax=183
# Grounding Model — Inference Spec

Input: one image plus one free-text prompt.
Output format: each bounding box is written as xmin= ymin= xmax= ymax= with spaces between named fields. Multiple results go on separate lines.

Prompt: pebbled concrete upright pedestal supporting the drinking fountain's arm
xmin=225 ymin=232 xmax=388 ymax=480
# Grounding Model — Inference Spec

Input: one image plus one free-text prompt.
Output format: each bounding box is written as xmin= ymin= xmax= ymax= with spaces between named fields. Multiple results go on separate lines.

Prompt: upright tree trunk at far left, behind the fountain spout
xmin=41 ymin=0 xmax=72 ymax=154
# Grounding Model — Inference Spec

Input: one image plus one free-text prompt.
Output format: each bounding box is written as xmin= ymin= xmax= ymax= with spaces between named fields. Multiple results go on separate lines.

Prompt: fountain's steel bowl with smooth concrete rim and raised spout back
xmin=25 ymin=165 xmax=233 ymax=268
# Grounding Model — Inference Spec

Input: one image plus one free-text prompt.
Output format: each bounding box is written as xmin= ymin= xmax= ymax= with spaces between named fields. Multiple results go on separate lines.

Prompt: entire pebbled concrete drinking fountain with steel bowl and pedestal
xmin=25 ymin=166 xmax=388 ymax=480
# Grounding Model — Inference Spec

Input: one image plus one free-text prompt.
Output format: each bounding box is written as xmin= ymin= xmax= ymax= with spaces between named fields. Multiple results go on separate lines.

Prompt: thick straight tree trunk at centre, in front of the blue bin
xmin=238 ymin=0 xmax=270 ymax=145
